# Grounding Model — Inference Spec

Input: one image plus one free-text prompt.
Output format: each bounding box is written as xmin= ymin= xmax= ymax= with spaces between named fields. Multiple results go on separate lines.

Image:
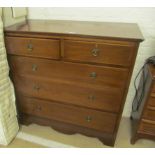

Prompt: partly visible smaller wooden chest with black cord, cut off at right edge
xmin=131 ymin=64 xmax=155 ymax=144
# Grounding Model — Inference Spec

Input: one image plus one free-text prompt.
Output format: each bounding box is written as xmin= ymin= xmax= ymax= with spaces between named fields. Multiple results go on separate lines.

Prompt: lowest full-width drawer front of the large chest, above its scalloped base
xmin=18 ymin=95 xmax=116 ymax=133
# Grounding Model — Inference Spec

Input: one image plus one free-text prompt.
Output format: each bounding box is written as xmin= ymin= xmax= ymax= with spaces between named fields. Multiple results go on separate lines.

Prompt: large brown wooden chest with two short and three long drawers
xmin=5 ymin=20 xmax=143 ymax=146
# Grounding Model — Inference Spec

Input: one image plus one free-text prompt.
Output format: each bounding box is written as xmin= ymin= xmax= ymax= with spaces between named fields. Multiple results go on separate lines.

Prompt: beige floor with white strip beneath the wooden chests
xmin=0 ymin=118 xmax=155 ymax=148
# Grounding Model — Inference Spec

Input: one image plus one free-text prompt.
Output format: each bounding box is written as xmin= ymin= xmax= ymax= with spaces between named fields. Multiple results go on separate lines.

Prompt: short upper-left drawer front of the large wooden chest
xmin=5 ymin=37 xmax=60 ymax=59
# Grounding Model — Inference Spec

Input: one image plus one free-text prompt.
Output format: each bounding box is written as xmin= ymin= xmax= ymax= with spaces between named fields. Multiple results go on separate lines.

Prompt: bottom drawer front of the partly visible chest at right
xmin=139 ymin=120 xmax=155 ymax=135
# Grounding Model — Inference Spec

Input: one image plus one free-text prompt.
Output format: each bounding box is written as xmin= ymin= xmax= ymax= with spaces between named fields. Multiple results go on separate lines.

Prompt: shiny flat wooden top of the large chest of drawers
xmin=5 ymin=20 xmax=143 ymax=42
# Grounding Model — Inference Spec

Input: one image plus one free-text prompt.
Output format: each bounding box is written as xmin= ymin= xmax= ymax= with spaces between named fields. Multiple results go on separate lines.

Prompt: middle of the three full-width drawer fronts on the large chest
xmin=14 ymin=76 xmax=123 ymax=112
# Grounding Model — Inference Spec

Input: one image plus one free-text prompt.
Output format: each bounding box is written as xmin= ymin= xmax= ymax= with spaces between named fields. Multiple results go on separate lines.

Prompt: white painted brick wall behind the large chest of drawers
xmin=29 ymin=8 xmax=155 ymax=116
